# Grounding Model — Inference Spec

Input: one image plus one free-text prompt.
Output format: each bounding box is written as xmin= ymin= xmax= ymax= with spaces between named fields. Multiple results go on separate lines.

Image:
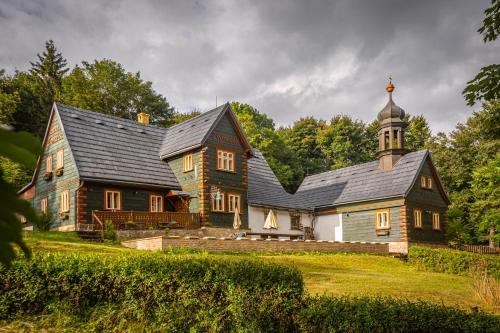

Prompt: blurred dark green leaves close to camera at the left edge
xmin=0 ymin=128 xmax=42 ymax=265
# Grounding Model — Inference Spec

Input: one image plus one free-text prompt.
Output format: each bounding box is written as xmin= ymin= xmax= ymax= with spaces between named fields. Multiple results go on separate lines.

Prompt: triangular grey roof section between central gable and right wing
xmin=248 ymin=149 xmax=305 ymax=209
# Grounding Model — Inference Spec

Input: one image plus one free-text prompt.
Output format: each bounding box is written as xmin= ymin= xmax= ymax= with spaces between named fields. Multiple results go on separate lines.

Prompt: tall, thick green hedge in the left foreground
xmin=0 ymin=253 xmax=304 ymax=332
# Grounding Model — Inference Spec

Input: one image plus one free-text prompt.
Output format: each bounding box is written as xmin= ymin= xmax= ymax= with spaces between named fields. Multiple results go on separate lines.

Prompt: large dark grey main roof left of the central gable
xmin=56 ymin=103 xmax=180 ymax=189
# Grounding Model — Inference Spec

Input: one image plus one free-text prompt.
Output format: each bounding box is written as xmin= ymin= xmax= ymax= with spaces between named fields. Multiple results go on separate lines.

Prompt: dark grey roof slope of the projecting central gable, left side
xmin=160 ymin=103 xmax=232 ymax=159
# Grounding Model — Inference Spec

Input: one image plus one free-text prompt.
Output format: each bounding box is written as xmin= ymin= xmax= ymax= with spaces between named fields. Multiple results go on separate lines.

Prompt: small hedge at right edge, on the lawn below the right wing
xmin=408 ymin=246 xmax=500 ymax=279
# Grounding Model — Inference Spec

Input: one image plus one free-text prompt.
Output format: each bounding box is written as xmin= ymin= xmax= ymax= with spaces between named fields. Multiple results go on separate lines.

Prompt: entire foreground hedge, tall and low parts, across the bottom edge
xmin=0 ymin=252 xmax=500 ymax=332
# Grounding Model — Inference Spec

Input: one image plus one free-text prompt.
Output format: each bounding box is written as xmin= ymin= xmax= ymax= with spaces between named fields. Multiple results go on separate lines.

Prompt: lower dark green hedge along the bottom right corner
xmin=296 ymin=296 xmax=500 ymax=332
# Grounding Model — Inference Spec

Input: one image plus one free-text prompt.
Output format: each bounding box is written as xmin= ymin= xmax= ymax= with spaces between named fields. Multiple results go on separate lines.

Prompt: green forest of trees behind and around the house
xmin=0 ymin=2 xmax=500 ymax=245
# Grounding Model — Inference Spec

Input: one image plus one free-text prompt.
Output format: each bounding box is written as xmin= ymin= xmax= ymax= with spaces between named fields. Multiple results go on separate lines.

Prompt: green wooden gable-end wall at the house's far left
xmin=33 ymin=113 xmax=79 ymax=227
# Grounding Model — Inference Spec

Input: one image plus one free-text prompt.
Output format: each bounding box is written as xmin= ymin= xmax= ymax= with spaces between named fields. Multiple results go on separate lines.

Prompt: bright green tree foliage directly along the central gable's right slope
xmin=231 ymin=102 xmax=300 ymax=191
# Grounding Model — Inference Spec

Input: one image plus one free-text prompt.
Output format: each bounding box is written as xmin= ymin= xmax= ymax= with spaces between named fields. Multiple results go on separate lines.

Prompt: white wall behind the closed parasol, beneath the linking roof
xmin=248 ymin=206 xmax=311 ymax=235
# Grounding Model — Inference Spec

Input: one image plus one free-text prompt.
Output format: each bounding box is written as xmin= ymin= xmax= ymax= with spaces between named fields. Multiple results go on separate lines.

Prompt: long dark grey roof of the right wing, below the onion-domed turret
xmin=295 ymin=150 xmax=428 ymax=208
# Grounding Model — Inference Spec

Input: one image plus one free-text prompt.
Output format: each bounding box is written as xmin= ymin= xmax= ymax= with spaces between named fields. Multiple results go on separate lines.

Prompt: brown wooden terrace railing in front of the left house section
xmin=92 ymin=210 xmax=200 ymax=230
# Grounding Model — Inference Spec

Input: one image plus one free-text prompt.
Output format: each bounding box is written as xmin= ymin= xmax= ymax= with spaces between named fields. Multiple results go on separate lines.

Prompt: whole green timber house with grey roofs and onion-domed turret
xmin=21 ymin=83 xmax=450 ymax=251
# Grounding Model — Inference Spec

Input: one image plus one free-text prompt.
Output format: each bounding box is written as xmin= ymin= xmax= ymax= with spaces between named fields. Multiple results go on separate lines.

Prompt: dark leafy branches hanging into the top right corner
xmin=462 ymin=0 xmax=500 ymax=106
